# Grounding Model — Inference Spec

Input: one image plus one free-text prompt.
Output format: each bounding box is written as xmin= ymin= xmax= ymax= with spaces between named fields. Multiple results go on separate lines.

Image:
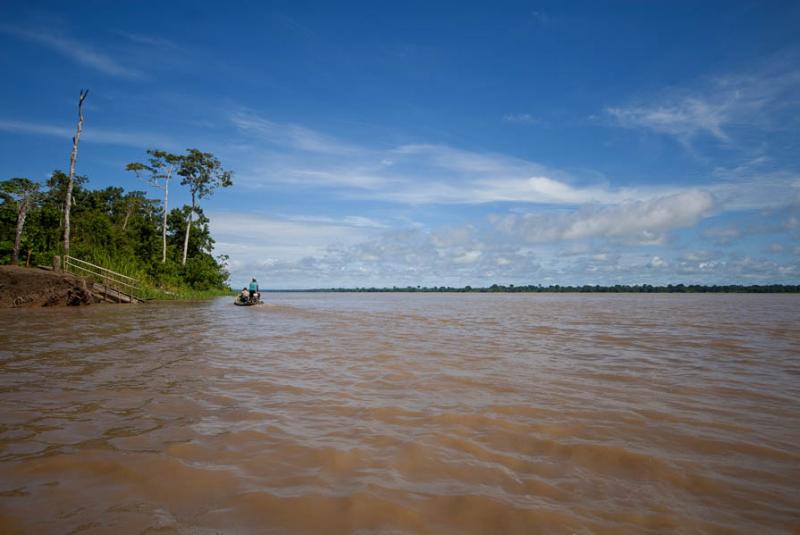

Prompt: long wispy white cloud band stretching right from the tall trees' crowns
xmin=229 ymin=113 xmax=800 ymax=214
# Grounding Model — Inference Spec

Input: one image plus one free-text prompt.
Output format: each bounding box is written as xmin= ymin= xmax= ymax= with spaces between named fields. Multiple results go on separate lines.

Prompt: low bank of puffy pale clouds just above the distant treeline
xmin=219 ymin=209 xmax=798 ymax=288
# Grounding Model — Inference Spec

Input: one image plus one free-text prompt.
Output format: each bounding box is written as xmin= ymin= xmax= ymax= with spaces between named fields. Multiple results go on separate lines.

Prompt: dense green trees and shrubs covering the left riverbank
xmin=0 ymin=149 xmax=231 ymax=299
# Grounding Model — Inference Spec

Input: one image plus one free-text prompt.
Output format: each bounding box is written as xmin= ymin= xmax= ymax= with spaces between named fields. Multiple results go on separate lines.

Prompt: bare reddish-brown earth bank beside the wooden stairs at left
xmin=0 ymin=266 xmax=100 ymax=308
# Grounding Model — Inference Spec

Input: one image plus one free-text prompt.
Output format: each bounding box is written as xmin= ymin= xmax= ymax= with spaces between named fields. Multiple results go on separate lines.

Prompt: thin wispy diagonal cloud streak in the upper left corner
xmin=0 ymin=24 xmax=141 ymax=78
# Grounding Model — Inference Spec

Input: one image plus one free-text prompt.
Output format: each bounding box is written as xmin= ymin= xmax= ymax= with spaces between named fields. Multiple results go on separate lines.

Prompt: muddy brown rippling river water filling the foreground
xmin=0 ymin=293 xmax=800 ymax=534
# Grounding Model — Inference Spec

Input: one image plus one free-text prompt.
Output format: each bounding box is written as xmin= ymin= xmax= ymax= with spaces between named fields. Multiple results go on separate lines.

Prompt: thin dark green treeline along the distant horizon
xmin=265 ymin=284 xmax=800 ymax=293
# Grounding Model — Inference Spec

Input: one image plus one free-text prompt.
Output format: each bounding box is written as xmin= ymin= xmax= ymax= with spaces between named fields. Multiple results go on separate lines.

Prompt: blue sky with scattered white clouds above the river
xmin=0 ymin=0 xmax=800 ymax=289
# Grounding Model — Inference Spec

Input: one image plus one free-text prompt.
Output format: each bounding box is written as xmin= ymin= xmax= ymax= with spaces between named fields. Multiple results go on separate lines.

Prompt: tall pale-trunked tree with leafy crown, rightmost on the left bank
xmin=178 ymin=149 xmax=233 ymax=266
